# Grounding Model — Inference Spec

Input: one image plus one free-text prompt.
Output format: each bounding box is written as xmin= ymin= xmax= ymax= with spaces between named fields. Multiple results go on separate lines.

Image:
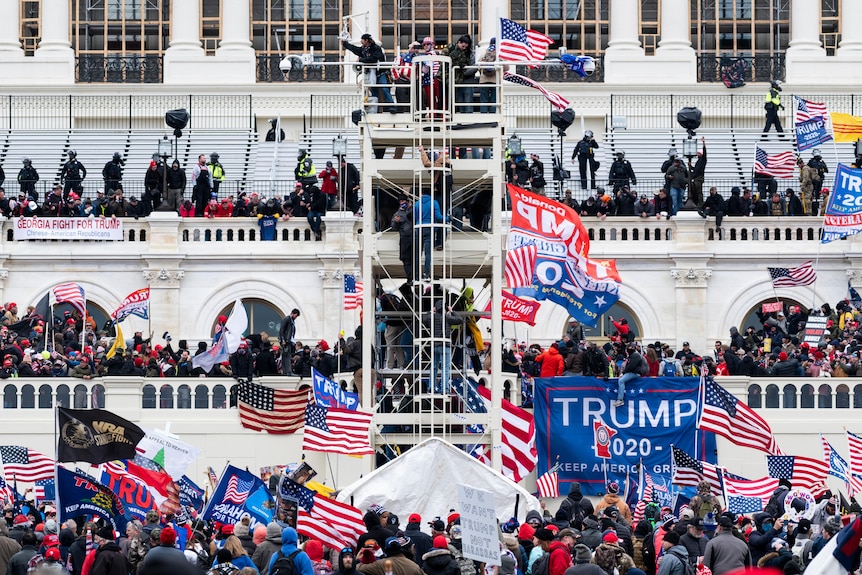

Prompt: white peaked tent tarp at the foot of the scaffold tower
xmin=337 ymin=437 xmax=542 ymax=531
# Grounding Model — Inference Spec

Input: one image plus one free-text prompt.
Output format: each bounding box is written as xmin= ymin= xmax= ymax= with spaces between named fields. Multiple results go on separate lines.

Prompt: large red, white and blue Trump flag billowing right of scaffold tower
xmin=508 ymin=184 xmax=620 ymax=327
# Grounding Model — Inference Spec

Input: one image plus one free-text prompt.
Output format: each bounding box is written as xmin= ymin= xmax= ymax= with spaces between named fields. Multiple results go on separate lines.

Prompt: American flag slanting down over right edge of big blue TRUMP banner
xmin=698 ymin=377 xmax=784 ymax=455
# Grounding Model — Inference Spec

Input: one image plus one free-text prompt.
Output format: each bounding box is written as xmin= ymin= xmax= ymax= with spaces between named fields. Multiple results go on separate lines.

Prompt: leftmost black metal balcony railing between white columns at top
xmin=75 ymin=54 xmax=164 ymax=84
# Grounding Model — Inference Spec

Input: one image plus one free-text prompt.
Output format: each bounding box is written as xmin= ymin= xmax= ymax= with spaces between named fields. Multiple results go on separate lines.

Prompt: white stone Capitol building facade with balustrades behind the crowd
xmin=0 ymin=0 xmax=862 ymax=491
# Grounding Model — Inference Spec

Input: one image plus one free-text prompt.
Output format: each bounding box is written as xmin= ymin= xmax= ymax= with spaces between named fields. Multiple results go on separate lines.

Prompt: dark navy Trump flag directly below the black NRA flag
xmin=56 ymin=467 xmax=130 ymax=533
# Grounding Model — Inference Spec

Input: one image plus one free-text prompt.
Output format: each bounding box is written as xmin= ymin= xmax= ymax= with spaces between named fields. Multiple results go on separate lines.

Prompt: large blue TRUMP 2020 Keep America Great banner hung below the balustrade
xmin=533 ymin=377 xmax=716 ymax=495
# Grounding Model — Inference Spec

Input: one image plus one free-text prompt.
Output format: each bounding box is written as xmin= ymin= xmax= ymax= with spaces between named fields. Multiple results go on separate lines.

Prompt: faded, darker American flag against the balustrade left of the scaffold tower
xmin=236 ymin=381 xmax=308 ymax=433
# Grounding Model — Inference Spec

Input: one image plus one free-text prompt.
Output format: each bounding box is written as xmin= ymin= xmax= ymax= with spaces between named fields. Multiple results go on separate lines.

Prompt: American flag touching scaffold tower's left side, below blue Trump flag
xmin=302 ymin=403 xmax=374 ymax=455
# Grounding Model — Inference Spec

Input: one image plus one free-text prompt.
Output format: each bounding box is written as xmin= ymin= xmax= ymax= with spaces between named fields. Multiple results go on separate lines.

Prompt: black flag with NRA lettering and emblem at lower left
xmin=57 ymin=407 xmax=146 ymax=465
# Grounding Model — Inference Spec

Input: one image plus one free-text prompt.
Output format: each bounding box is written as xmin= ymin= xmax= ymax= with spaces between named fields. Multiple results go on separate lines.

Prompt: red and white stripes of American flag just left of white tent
xmin=296 ymin=493 xmax=366 ymax=549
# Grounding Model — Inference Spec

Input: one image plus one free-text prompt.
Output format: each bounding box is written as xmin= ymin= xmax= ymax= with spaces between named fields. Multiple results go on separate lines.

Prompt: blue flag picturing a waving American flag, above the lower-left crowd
xmin=202 ymin=465 xmax=275 ymax=528
